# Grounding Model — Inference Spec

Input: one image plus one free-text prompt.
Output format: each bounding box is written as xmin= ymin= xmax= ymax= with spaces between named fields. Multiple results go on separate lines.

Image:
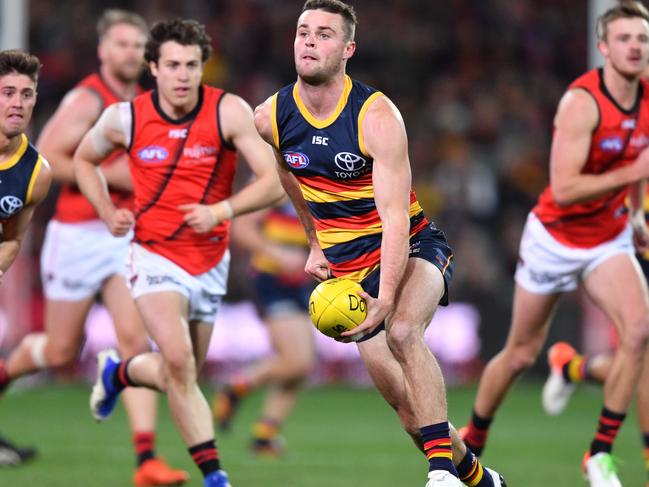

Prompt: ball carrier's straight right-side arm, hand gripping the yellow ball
xmin=342 ymin=97 xmax=412 ymax=336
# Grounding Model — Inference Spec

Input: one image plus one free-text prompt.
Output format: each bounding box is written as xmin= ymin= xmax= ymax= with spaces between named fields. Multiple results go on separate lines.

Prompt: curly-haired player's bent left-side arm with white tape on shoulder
xmin=73 ymin=104 xmax=134 ymax=236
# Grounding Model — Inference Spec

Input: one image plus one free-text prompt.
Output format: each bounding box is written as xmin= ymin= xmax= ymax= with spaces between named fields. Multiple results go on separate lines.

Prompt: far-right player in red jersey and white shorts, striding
xmin=463 ymin=2 xmax=649 ymax=486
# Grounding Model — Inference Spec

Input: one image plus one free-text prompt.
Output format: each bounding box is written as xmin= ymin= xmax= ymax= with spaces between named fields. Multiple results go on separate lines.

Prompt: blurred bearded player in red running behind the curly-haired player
xmin=0 ymin=10 xmax=187 ymax=485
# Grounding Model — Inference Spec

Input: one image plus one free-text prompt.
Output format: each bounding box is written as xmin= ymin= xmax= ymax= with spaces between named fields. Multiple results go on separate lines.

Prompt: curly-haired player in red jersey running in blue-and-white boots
xmin=74 ymin=19 xmax=282 ymax=487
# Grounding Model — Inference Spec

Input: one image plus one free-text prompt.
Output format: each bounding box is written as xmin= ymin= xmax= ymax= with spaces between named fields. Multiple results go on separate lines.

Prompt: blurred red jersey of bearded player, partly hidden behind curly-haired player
xmin=53 ymin=73 xmax=142 ymax=223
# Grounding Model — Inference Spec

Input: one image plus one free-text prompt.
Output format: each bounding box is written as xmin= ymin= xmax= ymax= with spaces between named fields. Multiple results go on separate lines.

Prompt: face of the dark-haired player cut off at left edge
xmin=0 ymin=73 xmax=36 ymax=138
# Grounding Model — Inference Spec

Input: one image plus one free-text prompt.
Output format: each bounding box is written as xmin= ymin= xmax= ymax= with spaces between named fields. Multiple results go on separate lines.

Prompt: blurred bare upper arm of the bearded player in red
xmin=36 ymin=88 xmax=102 ymax=183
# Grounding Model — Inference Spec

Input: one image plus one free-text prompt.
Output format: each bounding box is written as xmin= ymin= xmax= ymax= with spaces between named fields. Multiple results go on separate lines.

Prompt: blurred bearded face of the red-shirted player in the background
xmin=99 ymin=24 xmax=146 ymax=83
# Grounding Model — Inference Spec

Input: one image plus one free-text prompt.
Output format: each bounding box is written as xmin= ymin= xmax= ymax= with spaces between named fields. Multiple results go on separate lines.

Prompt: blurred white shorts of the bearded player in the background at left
xmin=41 ymin=220 xmax=133 ymax=301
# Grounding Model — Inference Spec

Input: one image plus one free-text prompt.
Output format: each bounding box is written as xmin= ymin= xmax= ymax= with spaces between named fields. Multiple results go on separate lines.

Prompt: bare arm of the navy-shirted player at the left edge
xmin=0 ymin=159 xmax=52 ymax=277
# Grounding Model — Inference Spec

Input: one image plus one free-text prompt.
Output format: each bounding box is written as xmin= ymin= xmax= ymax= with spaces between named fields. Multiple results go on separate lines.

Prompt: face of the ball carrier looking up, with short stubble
xmin=294 ymin=10 xmax=356 ymax=85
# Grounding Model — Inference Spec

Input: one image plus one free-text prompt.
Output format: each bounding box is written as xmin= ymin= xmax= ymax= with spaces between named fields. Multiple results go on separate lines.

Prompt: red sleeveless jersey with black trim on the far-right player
xmin=532 ymin=68 xmax=649 ymax=248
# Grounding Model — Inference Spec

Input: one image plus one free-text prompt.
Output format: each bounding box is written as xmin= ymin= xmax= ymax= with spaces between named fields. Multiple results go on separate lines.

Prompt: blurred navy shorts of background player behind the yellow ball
xmin=254 ymin=272 xmax=315 ymax=316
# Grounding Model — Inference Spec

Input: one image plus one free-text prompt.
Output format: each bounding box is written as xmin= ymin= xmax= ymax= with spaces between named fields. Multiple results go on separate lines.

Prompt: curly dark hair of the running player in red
xmin=144 ymin=19 xmax=212 ymax=63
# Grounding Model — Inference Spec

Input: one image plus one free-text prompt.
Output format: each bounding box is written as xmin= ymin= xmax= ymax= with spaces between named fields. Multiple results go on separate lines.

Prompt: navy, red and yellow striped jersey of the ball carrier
xmin=271 ymin=76 xmax=428 ymax=281
